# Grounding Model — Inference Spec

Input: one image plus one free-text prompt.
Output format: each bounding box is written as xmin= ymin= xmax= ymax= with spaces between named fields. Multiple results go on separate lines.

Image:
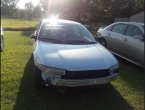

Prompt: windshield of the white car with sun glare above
xmin=38 ymin=23 xmax=96 ymax=45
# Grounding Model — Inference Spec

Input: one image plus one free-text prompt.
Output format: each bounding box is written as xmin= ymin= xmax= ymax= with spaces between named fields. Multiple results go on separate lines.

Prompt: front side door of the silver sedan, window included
xmin=124 ymin=25 xmax=144 ymax=64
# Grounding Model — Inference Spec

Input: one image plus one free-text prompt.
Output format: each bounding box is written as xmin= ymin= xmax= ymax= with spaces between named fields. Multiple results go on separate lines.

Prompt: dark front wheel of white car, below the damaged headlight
xmin=34 ymin=66 xmax=46 ymax=89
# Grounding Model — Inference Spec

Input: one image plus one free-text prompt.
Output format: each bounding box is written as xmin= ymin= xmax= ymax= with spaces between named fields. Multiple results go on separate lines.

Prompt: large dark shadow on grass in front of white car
xmin=13 ymin=56 xmax=133 ymax=110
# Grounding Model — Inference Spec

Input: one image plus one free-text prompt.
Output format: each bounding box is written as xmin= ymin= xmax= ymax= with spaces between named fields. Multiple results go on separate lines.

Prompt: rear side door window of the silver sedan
xmin=112 ymin=24 xmax=127 ymax=34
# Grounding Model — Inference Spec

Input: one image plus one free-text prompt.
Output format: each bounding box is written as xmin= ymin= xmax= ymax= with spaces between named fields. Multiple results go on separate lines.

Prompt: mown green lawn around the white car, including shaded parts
xmin=1 ymin=31 xmax=144 ymax=110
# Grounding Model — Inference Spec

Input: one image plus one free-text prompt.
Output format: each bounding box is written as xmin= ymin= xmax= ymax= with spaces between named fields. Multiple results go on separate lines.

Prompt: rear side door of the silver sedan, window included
xmin=108 ymin=23 xmax=127 ymax=55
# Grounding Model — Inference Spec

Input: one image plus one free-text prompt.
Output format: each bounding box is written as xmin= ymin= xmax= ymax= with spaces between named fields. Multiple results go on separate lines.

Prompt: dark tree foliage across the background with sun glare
xmin=1 ymin=0 xmax=144 ymax=23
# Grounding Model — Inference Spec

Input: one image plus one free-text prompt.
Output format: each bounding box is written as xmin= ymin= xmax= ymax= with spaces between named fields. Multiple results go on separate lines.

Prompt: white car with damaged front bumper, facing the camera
xmin=31 ymin=19 xmax=119 ymax=88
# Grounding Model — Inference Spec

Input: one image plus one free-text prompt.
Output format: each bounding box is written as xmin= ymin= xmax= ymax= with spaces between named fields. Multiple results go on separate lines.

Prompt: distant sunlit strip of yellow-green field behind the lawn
xmin=1 ymin=19 xmax=38 ymax=28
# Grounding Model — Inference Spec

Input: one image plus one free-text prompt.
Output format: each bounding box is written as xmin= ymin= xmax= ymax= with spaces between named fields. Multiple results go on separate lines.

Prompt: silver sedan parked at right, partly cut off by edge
xmin=97 ymin=22 xmax=144 ymax=66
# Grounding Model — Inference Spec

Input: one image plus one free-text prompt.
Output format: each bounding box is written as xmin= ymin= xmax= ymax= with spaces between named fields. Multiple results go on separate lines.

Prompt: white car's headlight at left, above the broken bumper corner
xmin=37 ymin=65 xmax=65 ymax=75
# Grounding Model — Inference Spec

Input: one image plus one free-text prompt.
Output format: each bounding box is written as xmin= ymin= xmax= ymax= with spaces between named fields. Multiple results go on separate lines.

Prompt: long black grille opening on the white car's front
xmin=61 ymin=69 xmax=110 ymax=79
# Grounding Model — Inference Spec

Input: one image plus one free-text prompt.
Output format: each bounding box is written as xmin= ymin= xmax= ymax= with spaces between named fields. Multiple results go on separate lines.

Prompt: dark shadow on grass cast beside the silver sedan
xmin=116 ymin=56 xmax=144 ymax=91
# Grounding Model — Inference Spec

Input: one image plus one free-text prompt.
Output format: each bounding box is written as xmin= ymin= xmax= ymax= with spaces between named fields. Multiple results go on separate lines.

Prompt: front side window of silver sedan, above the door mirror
xmin=126 ymin=25 xmax=143 ymax=37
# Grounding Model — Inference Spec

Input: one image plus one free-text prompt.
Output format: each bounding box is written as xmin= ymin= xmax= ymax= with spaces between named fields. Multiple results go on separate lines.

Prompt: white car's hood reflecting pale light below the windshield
xmin=37 ymin=41 xmax=117 ymax=71
